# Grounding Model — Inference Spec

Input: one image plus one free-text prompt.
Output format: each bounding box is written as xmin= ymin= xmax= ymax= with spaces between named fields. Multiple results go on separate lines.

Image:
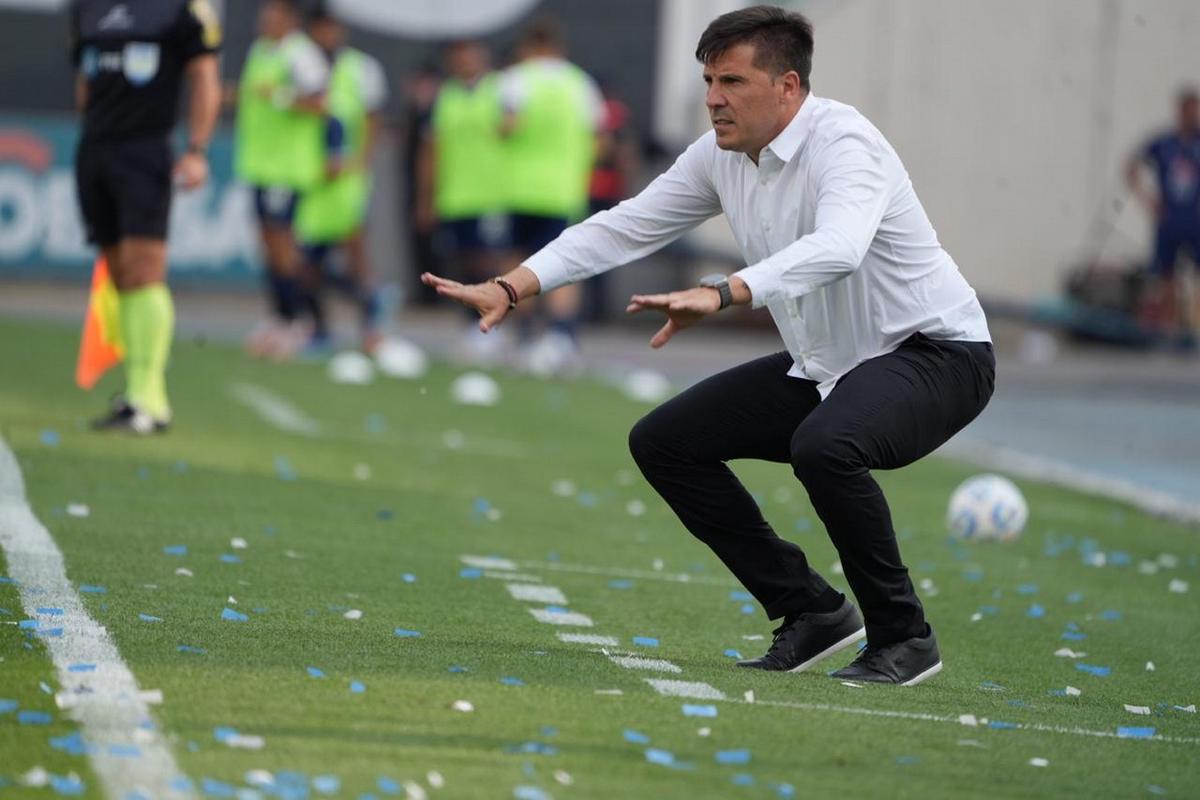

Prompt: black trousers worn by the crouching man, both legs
xmin=629 ymin=333 xmax=996 ymax=646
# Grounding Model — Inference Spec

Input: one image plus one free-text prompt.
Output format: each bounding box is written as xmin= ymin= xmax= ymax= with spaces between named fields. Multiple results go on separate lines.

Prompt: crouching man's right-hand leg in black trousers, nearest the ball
xmin=791 ymin=335 xmax=995 ymax=682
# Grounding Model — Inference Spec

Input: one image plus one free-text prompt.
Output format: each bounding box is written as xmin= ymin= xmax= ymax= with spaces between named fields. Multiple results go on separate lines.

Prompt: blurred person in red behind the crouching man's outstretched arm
xmin=586 ymin=80 xmax=637 ymax=320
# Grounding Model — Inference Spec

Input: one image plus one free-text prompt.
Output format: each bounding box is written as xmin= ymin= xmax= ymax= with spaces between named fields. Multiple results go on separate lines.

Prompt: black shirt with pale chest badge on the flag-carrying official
xmin=71 ymin=0 xmax=221 ymax=142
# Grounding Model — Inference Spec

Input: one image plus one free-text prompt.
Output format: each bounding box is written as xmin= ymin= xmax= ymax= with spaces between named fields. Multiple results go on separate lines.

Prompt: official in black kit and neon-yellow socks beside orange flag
xmin=71 ymin=0 xmax=221 ymax=434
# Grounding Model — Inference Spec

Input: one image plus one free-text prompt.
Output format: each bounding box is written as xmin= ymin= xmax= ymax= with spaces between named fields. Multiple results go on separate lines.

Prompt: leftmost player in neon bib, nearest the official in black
xmin=234 ymin=0 xmax=329 ymax=357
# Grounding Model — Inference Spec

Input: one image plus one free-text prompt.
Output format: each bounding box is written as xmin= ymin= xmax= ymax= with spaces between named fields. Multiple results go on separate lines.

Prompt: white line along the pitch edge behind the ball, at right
xmin=937 ymin=439 xmax=1200 ymax=523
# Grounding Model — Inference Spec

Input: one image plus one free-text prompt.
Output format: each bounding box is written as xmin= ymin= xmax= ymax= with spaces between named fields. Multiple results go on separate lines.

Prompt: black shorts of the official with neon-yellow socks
xmin=76 ymin=137 xmax=174 ymax=247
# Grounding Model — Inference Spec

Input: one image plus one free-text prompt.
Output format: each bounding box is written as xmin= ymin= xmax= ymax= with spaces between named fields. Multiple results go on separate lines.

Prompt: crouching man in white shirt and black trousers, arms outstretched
xmin=424 ymin=6 xmax=995 ymax=685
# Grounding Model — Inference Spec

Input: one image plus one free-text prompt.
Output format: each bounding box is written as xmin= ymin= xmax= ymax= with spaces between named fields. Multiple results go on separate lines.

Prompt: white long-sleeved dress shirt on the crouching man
xmin=524 ymin=95 xmax=991 ymax=398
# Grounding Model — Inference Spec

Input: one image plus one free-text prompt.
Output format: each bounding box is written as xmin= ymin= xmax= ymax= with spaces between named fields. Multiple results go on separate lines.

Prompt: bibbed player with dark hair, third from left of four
xmin=416 ymin=41 xmax=506 ymax=361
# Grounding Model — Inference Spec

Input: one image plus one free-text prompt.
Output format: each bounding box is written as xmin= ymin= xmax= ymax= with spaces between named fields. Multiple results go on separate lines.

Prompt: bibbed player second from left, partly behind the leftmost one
xmin=295 ymin=8 xmax=388 ymax=353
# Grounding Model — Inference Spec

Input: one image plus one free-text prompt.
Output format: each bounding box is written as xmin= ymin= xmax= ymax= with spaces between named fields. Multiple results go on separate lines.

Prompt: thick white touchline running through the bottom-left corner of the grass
xmin=0 ymin=439 xmax=194 ymax=799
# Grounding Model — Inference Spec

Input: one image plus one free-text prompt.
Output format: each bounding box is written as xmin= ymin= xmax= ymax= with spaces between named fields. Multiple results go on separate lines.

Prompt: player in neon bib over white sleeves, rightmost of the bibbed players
xmin=500 ymin=20 xmax=604 ymax=374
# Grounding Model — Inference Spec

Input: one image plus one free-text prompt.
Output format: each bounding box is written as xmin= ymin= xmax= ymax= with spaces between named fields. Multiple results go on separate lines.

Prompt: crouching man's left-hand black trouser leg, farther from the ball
xmin=629 ymin=353 xmax=839 ymax=619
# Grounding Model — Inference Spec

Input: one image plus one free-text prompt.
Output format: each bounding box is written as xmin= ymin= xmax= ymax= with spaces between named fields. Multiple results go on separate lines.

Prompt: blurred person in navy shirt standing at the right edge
xmin=1126 ymin=88 xmax=1200 ymax=347
